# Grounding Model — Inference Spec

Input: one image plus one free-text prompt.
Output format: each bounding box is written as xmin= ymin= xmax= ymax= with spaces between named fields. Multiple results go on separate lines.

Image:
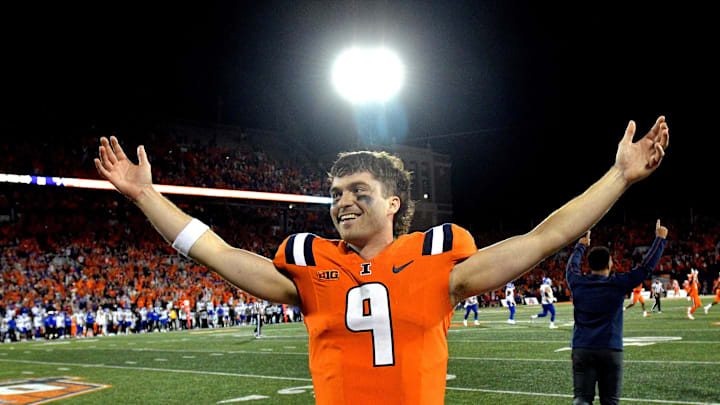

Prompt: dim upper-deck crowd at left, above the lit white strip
xmin=0 ymin=124 xmax=327 ymax=195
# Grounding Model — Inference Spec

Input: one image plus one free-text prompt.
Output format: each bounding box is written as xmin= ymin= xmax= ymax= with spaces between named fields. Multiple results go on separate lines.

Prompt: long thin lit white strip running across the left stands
xmin=0 ymin=173 xmax=332 ymax=205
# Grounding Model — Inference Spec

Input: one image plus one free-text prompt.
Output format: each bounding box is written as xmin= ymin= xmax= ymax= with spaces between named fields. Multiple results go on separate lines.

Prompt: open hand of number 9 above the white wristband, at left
xmin=95 ymin=136 xmax=152 ymax=201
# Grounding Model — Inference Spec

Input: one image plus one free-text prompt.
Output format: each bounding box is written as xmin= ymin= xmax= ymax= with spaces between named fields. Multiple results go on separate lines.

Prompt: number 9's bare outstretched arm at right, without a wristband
xmin=450 ymin=117 xmax=669 ymax=304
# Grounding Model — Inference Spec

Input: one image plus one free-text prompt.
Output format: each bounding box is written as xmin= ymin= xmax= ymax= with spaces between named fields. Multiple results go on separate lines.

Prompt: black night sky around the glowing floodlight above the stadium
xmin=0 ymin=1 xmax=720 ymax=228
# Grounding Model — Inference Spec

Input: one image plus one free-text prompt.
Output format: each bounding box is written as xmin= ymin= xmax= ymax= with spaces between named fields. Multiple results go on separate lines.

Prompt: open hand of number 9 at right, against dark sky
xmin=615 ymin=116 xmax=670 ymax=184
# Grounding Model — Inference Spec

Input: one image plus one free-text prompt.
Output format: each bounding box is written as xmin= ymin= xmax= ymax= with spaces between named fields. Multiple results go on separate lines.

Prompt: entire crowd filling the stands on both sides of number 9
xmin=0 ymin=125 xmax=720 ymax=341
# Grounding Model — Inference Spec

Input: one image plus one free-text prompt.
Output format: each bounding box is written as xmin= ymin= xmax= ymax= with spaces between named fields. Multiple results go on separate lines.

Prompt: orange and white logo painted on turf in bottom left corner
xmin=0 ymin=377 xmax=110 ymax=404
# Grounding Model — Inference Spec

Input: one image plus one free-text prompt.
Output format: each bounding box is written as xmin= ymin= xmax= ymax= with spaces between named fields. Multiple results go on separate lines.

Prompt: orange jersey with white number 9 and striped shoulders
xmin=273 ymin=224 xmax=477 ymax=405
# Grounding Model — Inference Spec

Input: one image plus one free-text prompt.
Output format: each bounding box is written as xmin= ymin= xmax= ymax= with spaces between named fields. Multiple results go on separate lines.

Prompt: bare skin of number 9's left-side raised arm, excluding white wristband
xmin=95 ymin=136 xmax=299 ymax=305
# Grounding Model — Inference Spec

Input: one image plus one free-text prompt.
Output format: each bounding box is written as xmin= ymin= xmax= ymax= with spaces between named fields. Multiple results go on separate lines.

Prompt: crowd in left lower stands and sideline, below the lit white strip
xmin=0 ymin=185 xmax=332 ymax=340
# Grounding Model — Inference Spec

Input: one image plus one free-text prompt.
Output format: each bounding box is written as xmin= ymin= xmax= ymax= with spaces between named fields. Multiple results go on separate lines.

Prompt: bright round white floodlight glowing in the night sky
xmin=332 ymin=48 xmax=405 ymax=104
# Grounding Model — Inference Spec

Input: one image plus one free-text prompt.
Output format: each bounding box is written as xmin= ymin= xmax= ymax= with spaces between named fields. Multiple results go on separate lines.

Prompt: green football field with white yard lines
xmin=0 ymin=296 xmax=720 ymax=405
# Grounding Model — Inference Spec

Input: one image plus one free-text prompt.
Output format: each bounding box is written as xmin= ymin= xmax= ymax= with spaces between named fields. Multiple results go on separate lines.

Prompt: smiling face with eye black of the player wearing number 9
xmin=330 ymin=172 xmax=400 ymax=249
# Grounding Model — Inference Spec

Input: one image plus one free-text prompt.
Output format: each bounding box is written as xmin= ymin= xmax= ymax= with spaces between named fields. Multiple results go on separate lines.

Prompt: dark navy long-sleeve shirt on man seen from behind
xmin=565 ymin=238 xmax=667 ymax=350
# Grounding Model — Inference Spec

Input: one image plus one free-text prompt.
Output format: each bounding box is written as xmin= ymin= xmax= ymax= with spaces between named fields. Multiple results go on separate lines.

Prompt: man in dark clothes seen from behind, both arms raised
xmin=565 ymin=220 xmax=668 ymax=405
